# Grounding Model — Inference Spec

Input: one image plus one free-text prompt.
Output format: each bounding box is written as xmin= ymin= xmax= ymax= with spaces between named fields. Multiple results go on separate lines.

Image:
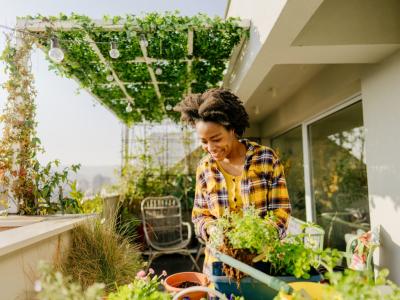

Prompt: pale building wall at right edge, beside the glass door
xmin=361 ymin=52 xmax=400 ymax=284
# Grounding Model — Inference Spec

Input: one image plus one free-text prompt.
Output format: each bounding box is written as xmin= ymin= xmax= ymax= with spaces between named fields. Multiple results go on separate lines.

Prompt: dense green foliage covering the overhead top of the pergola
xmin=18 ymin=13 xmax=248 ymax=125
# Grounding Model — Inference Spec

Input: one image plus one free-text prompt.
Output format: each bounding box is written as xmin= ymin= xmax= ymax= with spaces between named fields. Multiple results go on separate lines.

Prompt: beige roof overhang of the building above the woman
xmin=228 ymin=0 xmax=400 ymax=121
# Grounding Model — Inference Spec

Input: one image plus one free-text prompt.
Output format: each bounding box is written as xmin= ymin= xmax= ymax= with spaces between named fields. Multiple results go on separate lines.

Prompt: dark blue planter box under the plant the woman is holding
xmin=210 ymin=262 xmax=322 ymax=300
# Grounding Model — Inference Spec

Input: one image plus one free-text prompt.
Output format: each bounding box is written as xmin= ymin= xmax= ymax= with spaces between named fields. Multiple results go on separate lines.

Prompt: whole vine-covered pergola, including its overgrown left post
xmin=0 ymin=13 xmax=250 ymax=214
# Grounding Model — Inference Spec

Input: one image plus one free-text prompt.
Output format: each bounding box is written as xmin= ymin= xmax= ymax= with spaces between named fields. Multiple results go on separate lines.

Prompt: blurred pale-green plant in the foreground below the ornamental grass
xmin=34 ymin=261 xmax=104 ymax=300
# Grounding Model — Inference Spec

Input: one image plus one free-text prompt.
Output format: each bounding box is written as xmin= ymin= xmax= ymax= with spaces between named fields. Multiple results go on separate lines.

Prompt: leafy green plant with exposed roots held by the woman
xmin=210 ymin=208 xmax=340 ymax=279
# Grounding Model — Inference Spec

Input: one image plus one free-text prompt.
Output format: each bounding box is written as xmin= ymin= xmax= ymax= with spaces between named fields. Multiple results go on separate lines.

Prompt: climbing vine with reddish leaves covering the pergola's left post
xmin=0 ymin=36 xmax=40 ymax=213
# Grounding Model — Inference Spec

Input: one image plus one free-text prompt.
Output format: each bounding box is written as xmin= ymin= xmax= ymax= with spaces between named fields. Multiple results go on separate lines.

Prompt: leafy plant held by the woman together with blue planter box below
xmin=210 ymin=208 xmax=339 ymax=299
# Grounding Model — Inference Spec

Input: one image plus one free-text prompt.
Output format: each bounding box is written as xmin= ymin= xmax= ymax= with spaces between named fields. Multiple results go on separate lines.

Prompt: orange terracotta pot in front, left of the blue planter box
xmin=164 ymin=272 xmax=208 ymax=300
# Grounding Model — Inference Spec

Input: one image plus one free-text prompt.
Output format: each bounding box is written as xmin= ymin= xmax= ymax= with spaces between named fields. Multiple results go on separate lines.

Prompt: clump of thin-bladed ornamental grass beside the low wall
xmin=59 ymin=218 xmax=141 ymax=291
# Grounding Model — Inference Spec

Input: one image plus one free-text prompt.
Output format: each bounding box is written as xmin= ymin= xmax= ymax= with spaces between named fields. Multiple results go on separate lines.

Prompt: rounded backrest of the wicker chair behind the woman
xmin=141 ymin=196 xmax=183 ymax=247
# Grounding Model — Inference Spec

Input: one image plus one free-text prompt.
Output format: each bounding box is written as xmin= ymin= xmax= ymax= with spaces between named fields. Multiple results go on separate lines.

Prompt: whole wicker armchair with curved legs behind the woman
xmin=141 ymin=196 xmax=200 ymax=271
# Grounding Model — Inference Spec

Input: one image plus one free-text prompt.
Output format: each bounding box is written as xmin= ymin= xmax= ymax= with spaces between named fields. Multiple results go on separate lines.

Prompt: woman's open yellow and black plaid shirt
xmin=192 ymin=139 xmax=291 ymax=275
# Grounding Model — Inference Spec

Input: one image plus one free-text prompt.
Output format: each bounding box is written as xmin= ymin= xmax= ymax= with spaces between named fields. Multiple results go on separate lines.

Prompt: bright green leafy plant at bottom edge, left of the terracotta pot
xmin=108 ymin=271 xmax=172 ymax=300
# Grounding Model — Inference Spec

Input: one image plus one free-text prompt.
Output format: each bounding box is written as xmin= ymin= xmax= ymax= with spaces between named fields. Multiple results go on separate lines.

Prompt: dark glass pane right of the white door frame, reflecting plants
xmin=309 ymin=102 xmax=370 ymax=250
